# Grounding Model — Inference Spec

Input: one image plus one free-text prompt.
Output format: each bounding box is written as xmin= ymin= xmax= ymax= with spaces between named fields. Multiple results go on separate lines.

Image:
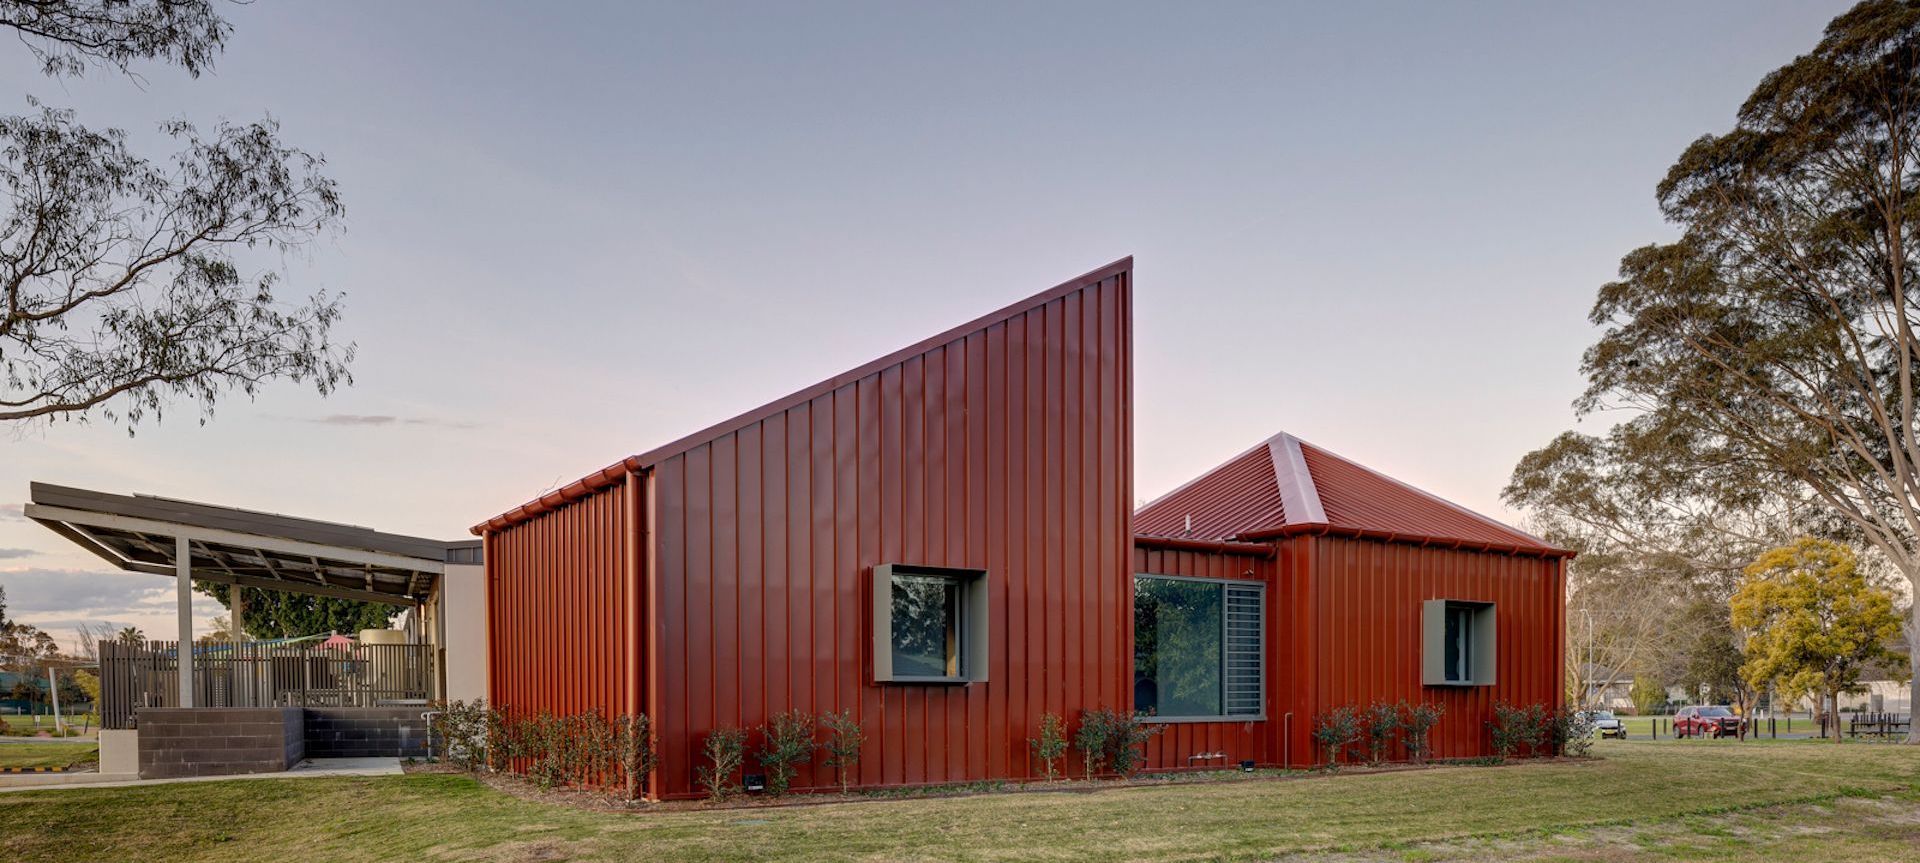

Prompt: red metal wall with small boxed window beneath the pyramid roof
xmin=1275 ymin=536 xmax=1567 ymax=763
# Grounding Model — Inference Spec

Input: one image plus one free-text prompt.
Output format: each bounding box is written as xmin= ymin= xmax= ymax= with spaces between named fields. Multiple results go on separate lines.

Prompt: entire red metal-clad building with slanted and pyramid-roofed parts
xmin=474 ymin=259 xmax=1565 ymax=798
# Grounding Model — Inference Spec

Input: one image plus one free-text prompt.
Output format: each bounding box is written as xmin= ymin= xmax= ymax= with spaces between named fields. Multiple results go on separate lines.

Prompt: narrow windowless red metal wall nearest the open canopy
xmin=486 ymin=477 xmax=639 ymax=719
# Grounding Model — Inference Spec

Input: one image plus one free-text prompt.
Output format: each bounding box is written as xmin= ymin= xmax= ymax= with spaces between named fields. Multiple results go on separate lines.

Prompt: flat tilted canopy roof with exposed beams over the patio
xmin=25 ymin=482 xmax=478 ymax=605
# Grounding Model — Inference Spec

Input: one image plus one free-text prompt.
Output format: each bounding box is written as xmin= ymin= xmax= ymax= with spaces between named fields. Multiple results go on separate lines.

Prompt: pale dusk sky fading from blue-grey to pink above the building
xmin=0 ymin=0 xmax=1847 ymax=638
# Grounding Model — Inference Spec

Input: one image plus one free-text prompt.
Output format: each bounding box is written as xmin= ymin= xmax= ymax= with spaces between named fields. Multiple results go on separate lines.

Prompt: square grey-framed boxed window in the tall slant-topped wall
xmin=874 ymin=563 xmax=987 ymax=682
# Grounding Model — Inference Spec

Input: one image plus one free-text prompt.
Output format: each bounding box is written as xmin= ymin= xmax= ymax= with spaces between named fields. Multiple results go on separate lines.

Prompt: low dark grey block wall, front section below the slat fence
xmin=136 ymin=707 xmax=307 ymax=778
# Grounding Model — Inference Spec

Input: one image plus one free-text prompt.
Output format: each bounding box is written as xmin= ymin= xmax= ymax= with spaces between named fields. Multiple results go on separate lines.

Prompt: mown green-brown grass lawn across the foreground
xmin=0 ymin=740 xmax=1920 ymax=863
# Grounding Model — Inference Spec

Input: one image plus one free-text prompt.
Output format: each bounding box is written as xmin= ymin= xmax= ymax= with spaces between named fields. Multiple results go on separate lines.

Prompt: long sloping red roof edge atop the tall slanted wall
xmin=472 ymin=256 xmax=1133 ymax=536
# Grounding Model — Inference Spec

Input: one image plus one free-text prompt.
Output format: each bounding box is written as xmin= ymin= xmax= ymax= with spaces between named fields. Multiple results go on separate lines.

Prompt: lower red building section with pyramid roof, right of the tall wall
xmin=1133 ymin=432 xmax=1572 ymax=767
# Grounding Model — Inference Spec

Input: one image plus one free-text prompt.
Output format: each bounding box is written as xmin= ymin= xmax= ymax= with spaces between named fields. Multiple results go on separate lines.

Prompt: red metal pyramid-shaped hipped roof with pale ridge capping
xmin=1133 ymin=432 xmax=1572 ymax=555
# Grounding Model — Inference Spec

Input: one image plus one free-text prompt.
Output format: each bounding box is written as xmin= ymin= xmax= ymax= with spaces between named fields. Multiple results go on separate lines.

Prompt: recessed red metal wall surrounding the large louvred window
xmin=1125 ymin=546 xmax=1284 ymax=771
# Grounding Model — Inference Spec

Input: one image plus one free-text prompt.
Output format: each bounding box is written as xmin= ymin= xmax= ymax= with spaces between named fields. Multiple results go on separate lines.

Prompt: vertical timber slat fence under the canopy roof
xmin=100 ymin=642 xmax=434 ymax=728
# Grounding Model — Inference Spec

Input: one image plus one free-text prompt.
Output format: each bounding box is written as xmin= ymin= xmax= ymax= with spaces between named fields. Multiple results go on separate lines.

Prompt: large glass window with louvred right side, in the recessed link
xmin=1133 ymin=575 xmax=1265 ymax=719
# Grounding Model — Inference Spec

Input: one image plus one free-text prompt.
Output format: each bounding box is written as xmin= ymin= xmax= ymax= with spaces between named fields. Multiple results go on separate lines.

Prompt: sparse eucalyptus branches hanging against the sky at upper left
xmin=0 ymin=0 xmax=353 ymax=432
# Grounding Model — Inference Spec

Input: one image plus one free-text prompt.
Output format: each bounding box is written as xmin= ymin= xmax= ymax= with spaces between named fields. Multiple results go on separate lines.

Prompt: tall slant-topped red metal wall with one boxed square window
xmin=653 ymin=267 xmax=1133 ymax=796
